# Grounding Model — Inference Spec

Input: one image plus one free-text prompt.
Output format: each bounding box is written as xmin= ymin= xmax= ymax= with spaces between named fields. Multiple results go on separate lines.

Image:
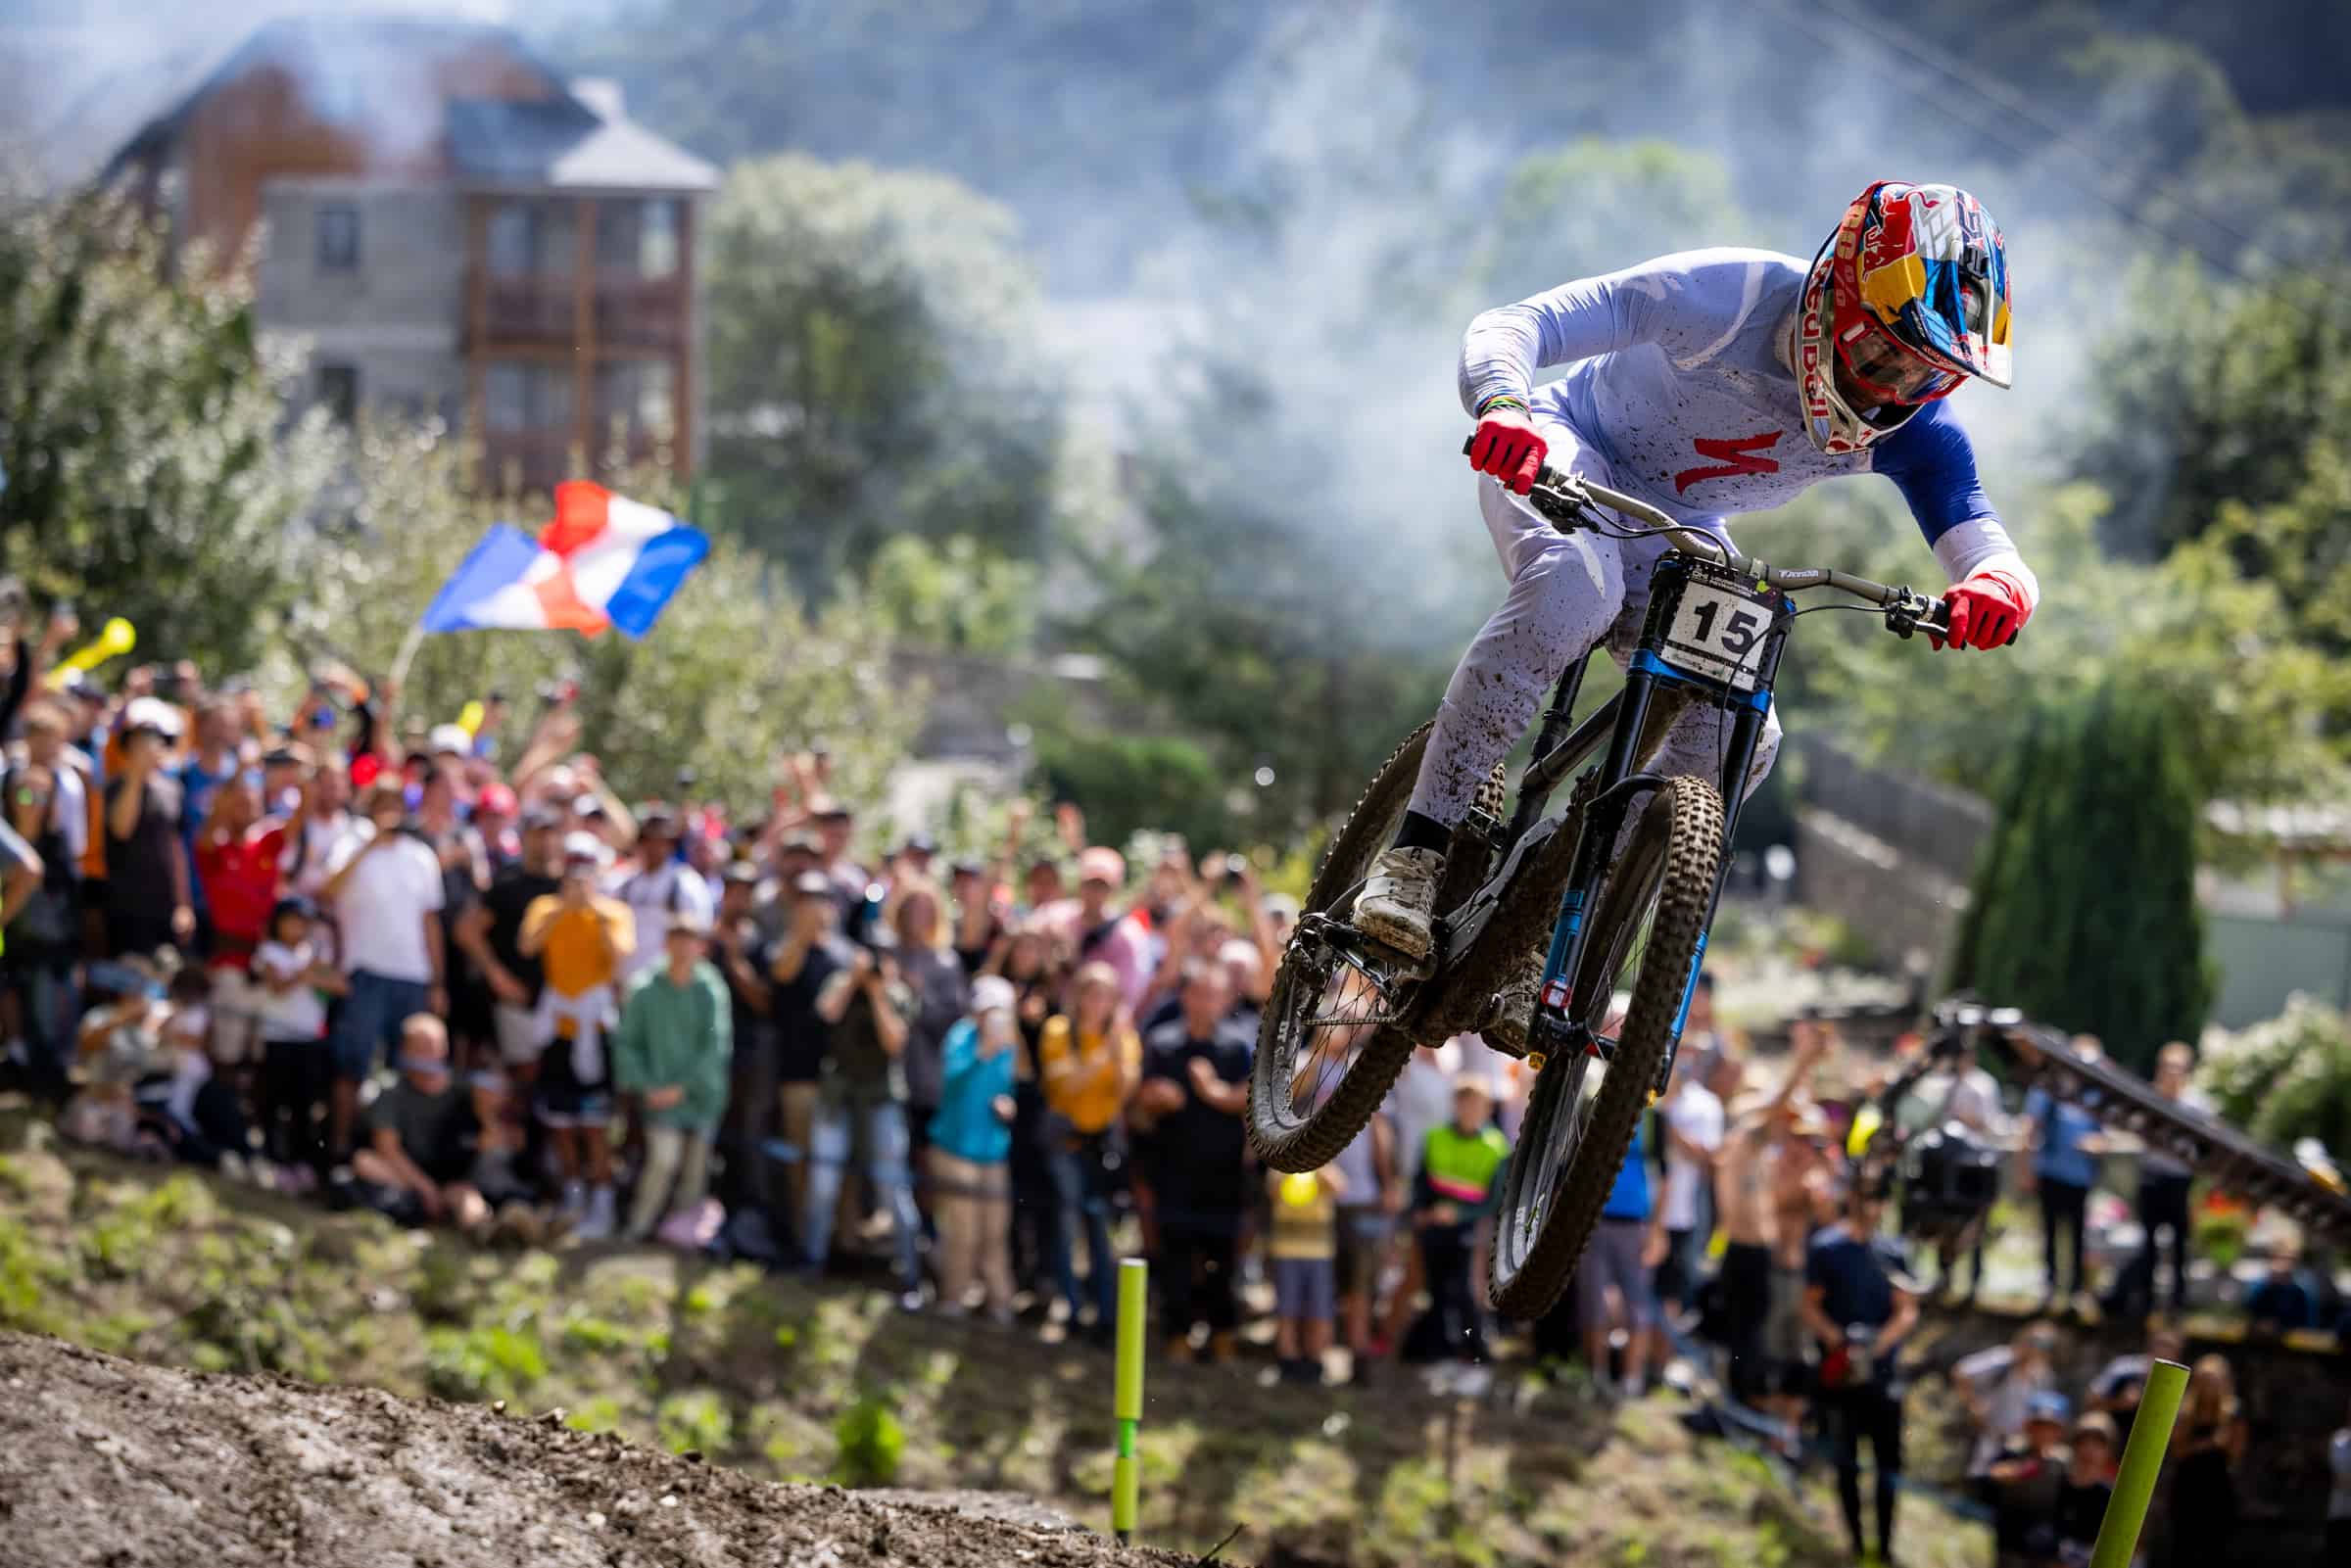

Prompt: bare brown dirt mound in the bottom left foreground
xmin=0 ymin=1333 xmax=1189 ymax=1568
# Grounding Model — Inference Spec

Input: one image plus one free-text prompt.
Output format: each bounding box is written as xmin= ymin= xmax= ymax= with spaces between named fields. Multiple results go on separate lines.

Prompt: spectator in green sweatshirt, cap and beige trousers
xmin=611 ymin=905 xmax=734 ymax=1241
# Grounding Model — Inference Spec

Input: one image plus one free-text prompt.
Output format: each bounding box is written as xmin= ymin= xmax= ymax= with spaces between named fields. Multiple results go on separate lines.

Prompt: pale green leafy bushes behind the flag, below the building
xmin=291 ymin=423 xmax=922 ymax=811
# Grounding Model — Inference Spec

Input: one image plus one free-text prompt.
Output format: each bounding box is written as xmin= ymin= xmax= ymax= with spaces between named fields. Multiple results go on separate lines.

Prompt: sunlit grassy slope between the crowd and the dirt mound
xmin=0 ymin=1152 xmax=1985 ymax=1568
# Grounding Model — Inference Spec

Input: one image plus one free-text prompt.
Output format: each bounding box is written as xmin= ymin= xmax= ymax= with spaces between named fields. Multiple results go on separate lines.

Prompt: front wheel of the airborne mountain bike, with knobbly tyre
xmin=1488 ymin=776 xmax=1723 ymax=1319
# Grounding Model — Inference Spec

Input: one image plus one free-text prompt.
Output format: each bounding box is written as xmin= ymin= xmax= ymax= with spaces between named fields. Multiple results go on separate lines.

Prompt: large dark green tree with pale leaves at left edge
xmin=0 ymin=180 xmax=336 ymax=670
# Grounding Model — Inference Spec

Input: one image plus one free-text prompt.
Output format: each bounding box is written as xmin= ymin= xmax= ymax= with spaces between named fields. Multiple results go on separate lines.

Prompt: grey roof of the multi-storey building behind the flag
xmin=106 ymin=17 xmax=717 ymax=190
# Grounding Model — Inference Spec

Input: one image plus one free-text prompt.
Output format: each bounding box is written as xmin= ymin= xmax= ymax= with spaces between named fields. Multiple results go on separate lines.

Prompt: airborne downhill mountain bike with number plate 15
xmin=1248 ymin=447 xmax=1949 ymax=1319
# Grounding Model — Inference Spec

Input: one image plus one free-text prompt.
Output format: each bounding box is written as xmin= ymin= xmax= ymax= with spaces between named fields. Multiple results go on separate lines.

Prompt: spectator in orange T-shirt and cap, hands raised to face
xmin=517 ymin=832 xmax=637 ymax=1241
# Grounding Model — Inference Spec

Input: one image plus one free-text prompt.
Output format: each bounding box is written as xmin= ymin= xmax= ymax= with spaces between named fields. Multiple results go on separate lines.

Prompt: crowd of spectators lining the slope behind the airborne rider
xmin=0 ymin=618 xmax=2351 ymax=1566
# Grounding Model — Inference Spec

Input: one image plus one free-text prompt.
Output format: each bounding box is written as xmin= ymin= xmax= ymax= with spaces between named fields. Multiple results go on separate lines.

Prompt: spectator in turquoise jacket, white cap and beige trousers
xmin=929 ymin=975 xmax=1020 ymax=1323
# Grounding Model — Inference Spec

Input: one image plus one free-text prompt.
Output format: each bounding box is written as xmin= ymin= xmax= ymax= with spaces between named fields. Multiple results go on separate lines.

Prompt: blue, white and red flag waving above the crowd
xmin=416 ymin=480 xmax=710 ymax=640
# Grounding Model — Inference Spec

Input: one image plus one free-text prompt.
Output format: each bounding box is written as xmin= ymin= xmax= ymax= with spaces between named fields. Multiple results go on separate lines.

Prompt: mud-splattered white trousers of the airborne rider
xmin=1413 ymin=421 xmax=1780 ymax=823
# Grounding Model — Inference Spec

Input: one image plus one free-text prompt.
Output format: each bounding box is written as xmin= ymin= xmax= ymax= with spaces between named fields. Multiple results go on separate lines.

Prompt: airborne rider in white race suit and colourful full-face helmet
xmin=1354 ymin=181 xmax=2039 ymax=1006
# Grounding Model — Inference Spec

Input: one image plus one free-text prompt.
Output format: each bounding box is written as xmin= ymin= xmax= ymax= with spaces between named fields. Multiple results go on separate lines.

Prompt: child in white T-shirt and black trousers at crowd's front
xmin=252 ymin=896 xmax=351 ymax=1192
